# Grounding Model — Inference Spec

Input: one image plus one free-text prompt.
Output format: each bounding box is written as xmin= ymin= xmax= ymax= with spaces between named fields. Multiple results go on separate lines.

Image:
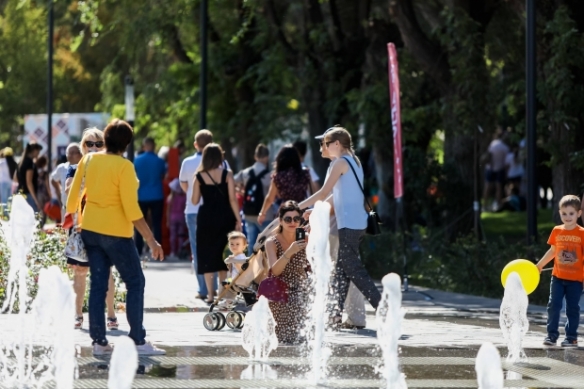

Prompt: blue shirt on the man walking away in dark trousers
xmin=134 ymin=151 xmax=166 ymax=201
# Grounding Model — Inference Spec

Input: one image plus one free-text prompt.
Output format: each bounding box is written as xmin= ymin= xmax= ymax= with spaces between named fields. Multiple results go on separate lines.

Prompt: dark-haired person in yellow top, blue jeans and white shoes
xmin=67 ymin=119 xmax=166 ymax=355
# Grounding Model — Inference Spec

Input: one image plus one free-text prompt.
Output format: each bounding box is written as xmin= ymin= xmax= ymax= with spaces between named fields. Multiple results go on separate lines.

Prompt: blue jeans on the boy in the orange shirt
xmin=547 ymin=276 xmax=582 ymax=340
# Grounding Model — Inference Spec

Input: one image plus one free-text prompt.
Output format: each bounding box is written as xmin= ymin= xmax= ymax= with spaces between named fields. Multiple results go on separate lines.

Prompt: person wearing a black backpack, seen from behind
xmin=233 ymin=143 xmax=275 ymax=255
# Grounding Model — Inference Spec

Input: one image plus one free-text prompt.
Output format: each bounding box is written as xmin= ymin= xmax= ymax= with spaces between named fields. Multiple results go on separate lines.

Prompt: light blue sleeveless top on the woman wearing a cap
xmin=333 ymin=156 xmax=367 ymax=230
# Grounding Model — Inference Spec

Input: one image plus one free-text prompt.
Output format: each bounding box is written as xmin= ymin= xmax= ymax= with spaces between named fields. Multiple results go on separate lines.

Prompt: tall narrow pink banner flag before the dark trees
xmin=387 ymin=43 xmax=404 ymax=199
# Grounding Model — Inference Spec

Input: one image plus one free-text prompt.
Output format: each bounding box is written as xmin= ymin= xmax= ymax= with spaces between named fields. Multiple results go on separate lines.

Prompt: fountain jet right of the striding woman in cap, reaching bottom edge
xmin=376 ymin=273 xmax=407 ymax=389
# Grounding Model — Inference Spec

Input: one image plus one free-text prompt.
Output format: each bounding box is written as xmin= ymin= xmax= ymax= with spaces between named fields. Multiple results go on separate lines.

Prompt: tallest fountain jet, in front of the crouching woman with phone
xmin=306 ymin=201 xmax=334 ymax=383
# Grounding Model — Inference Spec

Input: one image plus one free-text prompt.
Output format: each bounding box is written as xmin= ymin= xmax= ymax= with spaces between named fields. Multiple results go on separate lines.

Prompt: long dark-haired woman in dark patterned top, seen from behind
xmin=258 ymin=145 xmax=317 ymax=224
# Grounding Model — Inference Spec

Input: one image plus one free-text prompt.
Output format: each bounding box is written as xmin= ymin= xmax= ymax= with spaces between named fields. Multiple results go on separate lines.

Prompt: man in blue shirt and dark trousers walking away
xmin=134 ymin=137 xmax=166 ymax=255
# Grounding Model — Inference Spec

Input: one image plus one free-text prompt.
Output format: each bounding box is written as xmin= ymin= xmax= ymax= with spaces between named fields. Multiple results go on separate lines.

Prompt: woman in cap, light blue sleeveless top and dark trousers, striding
xmin=300 ymin=127 xmax=381 ymax=325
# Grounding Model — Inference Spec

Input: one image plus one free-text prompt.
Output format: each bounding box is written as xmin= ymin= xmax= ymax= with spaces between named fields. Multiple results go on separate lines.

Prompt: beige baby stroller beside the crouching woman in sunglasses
xmin=203 ymin=219 xmax=279 ymax=331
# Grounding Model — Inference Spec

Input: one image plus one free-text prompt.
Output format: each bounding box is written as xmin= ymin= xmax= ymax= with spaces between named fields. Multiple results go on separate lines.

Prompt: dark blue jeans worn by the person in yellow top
xmin=81 ymin=230 xmax=146 ymax=346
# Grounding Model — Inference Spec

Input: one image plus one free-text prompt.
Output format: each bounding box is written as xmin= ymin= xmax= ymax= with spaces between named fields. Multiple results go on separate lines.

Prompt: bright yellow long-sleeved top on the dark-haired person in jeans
xmin=67 ymin=153 xmax=143 ymax=238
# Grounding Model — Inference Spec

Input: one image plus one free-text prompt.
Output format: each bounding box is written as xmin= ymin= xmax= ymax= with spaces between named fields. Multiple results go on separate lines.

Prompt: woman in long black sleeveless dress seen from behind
xmin=191 ymin=143 xmax=241 ymax=304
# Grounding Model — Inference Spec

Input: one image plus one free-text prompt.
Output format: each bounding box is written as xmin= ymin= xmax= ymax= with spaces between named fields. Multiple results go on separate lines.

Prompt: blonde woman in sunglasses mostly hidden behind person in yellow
xmin=65 ymin=127 xmax=119 ymax=331
